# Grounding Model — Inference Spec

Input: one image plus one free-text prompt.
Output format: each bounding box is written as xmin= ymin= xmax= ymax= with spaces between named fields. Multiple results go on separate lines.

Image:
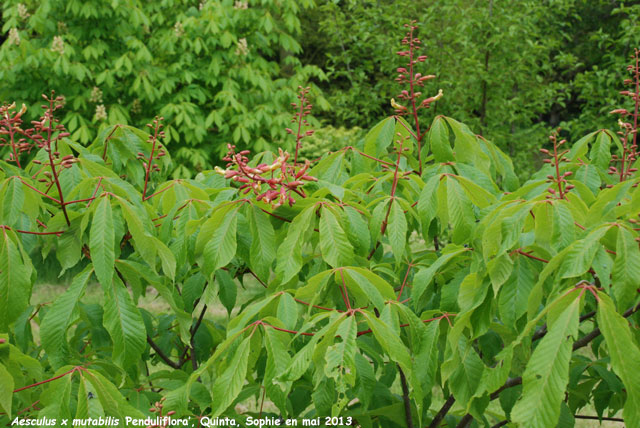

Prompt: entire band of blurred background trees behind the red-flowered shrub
xmin=0 ymin=0 xmax=640 ymax=178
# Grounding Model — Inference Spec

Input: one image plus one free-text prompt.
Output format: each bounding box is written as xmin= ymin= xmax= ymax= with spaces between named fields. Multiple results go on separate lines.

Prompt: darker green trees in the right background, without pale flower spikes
xmin=302 ymin=0 xmax=640 ymax=178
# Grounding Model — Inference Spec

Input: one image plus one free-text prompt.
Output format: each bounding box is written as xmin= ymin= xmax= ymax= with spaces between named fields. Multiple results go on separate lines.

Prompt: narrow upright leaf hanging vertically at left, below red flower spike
xmin=89 ymin=197 xmax=115 ymax=287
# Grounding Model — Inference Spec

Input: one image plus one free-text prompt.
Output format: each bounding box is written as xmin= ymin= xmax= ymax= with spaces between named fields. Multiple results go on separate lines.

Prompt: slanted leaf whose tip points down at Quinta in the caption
xmin=211 ymin=337 xmax=251 ymax=418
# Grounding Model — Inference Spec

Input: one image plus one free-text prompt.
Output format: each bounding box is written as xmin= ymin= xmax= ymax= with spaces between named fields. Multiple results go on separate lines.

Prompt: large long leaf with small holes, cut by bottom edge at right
xmin=511 ymin=299 xmax=580 ymax=428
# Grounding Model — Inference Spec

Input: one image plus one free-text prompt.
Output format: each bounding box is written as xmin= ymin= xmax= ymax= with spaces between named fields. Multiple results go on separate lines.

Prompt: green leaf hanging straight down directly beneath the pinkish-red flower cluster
xmin=248 ymin=205 xmax=276 ymax=280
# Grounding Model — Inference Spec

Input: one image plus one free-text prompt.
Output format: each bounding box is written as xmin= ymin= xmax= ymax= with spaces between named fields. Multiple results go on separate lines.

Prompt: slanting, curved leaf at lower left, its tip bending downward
xmin=40 ymin=265 xmax=93 ymax=369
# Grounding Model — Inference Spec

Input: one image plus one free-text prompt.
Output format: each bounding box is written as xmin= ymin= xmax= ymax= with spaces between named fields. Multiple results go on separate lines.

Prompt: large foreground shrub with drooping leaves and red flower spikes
xmin=0 ymin=22 xmax=640 ymax=427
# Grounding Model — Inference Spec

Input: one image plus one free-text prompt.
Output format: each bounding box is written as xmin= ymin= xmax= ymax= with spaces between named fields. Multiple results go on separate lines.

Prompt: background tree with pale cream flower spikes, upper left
xmin=0 ymin=0 xmax=326 ymax=177
